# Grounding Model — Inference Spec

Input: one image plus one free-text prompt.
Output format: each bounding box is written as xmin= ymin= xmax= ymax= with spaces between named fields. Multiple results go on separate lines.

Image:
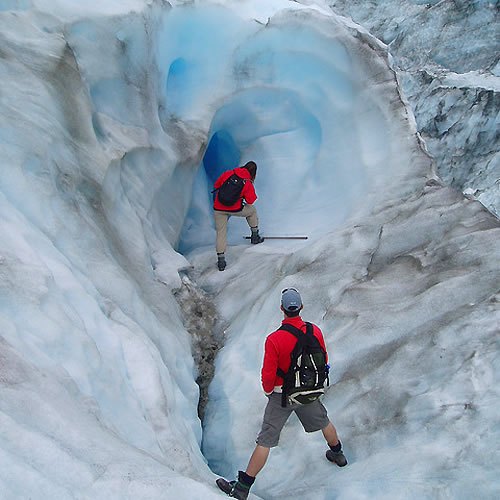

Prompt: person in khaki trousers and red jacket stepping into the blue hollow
xmin=214 ymin=161 xmax=264 ymax=271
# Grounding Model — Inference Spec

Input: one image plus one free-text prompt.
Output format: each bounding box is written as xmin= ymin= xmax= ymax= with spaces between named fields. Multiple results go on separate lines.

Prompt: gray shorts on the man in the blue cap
xmin=257 ymin=392 xmax=330 ymax=448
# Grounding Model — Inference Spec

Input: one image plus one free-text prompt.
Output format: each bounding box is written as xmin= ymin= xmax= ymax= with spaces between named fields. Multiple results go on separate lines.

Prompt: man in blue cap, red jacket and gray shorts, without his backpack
xmin=216 ymin=288 xmax=347 ymax=500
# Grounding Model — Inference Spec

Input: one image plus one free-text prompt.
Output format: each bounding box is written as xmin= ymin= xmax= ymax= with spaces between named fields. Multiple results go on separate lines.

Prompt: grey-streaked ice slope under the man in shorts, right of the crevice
xmin=199 ymin=182 xmax=500 ymax=500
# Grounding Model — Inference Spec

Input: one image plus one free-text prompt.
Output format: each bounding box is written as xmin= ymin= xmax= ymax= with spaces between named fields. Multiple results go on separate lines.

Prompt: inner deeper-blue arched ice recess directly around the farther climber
xmin=177 ymin=88 xmax=340 ymax=254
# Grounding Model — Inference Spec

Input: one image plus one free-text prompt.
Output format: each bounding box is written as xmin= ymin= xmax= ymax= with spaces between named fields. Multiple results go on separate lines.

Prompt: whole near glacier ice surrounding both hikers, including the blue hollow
xmin=0 ymin=0 xmax=500 ymax=500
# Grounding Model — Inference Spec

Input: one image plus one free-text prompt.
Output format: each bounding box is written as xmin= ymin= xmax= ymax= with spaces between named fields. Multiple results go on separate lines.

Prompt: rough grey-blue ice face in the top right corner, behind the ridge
xmin=328 ymin=0 xmax=500 ymax=216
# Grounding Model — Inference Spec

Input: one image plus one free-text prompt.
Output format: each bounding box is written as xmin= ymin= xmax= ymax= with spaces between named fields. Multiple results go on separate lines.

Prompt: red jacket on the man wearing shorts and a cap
xmin=261 ymin=316 xmax=328 ymax=394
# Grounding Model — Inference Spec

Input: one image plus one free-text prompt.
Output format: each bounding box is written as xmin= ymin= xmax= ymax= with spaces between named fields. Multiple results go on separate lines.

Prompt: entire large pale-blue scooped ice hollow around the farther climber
xmin=153 ymin=7 xmax=401 ymax=253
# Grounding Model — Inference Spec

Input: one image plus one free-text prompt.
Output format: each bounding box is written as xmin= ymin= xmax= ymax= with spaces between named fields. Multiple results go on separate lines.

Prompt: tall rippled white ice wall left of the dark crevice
xmin=0 ymin=2 xmax=219 ymax=499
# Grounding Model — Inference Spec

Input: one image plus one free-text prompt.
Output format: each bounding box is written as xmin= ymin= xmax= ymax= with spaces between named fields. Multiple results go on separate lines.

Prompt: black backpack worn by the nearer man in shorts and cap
xmin=276 ymin=323 xmax=329 ymax=407
